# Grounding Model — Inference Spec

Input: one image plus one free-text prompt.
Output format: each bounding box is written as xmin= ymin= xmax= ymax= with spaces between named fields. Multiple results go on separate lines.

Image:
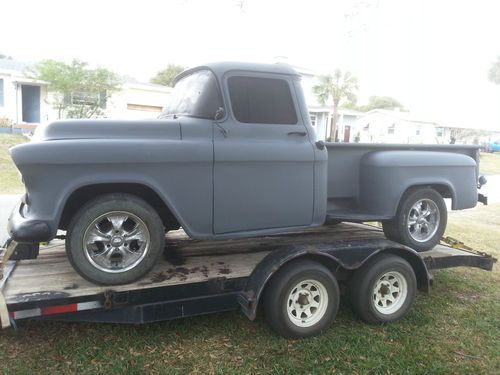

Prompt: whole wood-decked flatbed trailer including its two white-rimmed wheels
xmin=0 ymin=223 xmax=496 ymax=337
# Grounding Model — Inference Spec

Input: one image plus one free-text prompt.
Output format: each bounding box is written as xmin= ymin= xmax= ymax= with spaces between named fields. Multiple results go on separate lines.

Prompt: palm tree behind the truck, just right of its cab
xmin=313 ymin=69 xmax=359 ymax=142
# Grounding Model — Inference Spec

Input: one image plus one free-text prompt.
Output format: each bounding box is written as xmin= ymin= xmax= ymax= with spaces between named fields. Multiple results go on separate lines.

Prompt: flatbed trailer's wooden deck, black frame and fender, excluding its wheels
xmin=0 ymin=223 xmax=496 ymax=338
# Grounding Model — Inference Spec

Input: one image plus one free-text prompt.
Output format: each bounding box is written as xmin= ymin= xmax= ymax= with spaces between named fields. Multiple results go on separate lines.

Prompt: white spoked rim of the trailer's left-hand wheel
xmin=287 ymin=280 xmax=328 ymax=327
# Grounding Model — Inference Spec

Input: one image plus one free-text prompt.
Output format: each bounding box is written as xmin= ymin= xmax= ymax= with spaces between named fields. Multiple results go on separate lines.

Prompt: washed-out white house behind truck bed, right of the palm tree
xmin=351 ymin=109 xmax=440 ymax=144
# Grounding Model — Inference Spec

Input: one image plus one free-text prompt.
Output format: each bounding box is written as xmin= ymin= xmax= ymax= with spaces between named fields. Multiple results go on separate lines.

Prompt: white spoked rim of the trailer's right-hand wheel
xmin=373 ymin=271 xmax=408 ymax=315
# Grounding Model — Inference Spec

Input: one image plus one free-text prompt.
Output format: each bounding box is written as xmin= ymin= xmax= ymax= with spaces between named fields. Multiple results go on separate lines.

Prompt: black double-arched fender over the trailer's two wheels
xmin=238 ymin=239 xmax=431 ymax=320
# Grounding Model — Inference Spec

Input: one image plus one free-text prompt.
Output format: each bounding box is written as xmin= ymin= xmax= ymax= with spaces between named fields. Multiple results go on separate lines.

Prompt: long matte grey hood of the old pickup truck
xmin=33 ymin=120 xmax=181 ymax=141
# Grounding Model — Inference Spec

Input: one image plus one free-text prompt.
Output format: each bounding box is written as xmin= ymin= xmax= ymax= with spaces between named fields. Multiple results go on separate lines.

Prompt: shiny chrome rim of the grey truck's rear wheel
xmin=407 ymin=199 xmax=440 ymax=242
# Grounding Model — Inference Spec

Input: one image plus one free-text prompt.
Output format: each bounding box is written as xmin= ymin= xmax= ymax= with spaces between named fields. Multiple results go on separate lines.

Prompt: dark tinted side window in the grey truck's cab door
xmin=227 ymin=77 xmax=297 ymax=125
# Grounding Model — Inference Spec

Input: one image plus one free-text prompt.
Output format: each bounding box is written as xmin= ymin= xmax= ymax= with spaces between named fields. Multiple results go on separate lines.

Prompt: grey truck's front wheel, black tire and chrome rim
xmin=66 ymin=194 xmax=165 ymax=285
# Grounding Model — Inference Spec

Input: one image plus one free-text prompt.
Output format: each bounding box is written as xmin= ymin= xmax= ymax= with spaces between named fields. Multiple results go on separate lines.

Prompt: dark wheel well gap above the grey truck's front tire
xmin=59 ymin=183 xmax=180 ymax=230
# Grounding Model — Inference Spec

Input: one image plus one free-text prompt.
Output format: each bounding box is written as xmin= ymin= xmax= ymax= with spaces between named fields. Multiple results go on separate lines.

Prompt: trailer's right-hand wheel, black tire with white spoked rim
xmin=349 ymin=254 xmax=417 ymax=324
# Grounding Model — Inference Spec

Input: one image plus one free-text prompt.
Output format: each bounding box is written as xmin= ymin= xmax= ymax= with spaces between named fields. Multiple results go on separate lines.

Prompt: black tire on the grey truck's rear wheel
xmin=382 ymin=188 xmax=448 ymax=251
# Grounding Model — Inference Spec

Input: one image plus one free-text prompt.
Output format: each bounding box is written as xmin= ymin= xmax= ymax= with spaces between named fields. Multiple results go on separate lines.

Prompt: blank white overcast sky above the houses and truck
xmin=0 ymin=0 xmax=500 ymax=131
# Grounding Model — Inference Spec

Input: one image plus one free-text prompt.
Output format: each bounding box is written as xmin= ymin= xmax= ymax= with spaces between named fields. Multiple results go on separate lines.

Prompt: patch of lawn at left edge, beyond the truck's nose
xmin=0 ymin=134 xmax=27 ymax=194
